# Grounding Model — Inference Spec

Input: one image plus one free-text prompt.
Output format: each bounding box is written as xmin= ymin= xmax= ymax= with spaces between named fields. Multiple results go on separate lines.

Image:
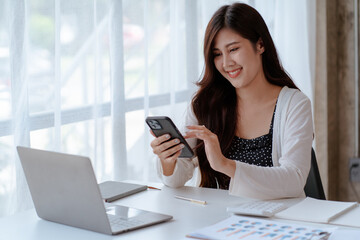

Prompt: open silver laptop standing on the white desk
xmin=17 ymin=146 xmax=172 ymax=235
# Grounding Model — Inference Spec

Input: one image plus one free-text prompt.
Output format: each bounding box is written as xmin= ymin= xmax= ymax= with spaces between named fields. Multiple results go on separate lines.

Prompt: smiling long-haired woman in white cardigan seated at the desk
xmin=151 ymin=3 xmax=313 ymax=199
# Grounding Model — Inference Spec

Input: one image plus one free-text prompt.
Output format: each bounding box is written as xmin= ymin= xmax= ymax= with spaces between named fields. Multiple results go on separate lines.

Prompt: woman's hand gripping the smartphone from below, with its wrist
xmin=150 ymin=130 xmax=184 ymax=176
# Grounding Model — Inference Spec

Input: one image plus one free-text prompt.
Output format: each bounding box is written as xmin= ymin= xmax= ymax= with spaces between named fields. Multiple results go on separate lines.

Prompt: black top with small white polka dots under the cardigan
xmin=225 ymin=105 xmax=276 ymax=167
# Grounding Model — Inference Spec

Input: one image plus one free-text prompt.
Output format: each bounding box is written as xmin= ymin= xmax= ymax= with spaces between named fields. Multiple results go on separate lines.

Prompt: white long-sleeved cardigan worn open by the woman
xmin=157 ymin=87 xmax=313 ymax=199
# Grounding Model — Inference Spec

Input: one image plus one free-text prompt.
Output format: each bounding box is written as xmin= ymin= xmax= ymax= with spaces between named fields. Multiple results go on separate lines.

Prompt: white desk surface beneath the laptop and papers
xmin=0 ymin=187 xmax=358 ymax=240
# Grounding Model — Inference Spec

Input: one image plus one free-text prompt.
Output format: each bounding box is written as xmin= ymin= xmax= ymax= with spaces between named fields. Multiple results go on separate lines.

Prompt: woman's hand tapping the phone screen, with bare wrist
xmin=185 ymin=125 xmax=236 ymax=177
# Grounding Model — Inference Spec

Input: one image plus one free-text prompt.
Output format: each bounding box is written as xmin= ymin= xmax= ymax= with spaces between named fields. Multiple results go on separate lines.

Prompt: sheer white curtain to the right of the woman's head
xmin=250 ymin=0 xmax=316 ymax=99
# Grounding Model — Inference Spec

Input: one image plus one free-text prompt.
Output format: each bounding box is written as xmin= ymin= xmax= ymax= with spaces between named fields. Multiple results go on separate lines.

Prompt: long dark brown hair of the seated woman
xmin=192 ymin=3 xmax=297 ymax=189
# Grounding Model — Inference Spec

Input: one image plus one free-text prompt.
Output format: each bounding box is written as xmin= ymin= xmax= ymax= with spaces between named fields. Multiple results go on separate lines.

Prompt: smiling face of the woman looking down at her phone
xmin=213 ymin=28 xmax=265 ymax=89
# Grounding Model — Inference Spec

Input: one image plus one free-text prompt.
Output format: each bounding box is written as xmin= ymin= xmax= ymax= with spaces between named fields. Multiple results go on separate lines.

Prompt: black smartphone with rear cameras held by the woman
xmin=145 ymin=116 xmax=194 ymax=158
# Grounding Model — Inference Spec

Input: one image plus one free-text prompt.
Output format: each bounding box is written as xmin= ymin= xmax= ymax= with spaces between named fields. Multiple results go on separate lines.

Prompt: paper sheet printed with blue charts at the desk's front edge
xmin=187 ymin=215 xmax=334 ymax=240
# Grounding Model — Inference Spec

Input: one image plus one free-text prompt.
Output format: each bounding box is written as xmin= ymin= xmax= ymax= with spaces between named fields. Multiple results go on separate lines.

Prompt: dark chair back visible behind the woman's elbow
xmin=304 ymin=148 xmax=326 ymax=200
